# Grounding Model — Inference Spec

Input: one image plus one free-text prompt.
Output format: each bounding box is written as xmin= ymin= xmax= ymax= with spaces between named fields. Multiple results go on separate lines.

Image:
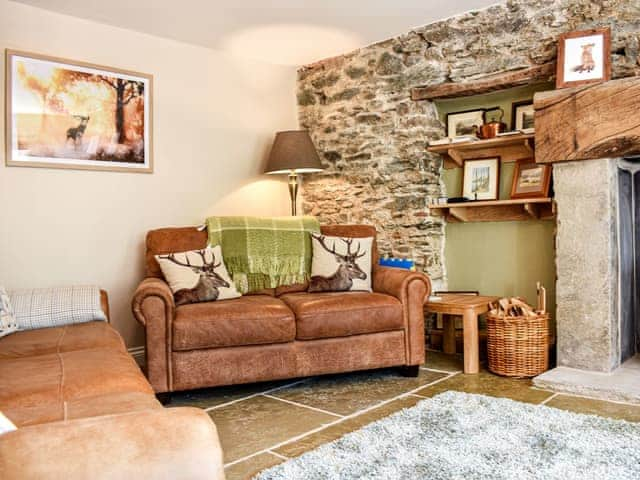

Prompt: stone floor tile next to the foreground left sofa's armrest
xmin=208 ymin=395 xmax=338 ymax=463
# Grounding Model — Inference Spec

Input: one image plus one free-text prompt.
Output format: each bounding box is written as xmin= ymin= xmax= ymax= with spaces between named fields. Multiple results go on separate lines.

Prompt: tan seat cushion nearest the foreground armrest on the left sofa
xmin=0 ymin=348 xmax=153 ymax=424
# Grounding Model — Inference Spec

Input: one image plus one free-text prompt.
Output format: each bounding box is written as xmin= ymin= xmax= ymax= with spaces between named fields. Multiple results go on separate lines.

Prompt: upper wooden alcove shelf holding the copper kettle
xmin=427 ymin=133 xmax=535 ymax=168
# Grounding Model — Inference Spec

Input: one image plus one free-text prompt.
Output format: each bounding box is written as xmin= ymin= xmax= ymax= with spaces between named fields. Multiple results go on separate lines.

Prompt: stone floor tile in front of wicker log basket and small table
xmin=416 ymin=371 xmax=553 ymax=403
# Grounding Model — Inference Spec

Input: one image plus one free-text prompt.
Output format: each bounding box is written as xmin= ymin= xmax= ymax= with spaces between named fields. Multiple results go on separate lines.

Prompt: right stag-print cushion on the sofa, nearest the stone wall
xmin=308 ymin=233 xmax=373 ymax=292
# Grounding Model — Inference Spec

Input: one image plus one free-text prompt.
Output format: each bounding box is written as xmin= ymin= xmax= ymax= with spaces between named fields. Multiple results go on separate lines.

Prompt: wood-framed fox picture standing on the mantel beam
xmin=556 ymin=28 xmax=611 ymax=88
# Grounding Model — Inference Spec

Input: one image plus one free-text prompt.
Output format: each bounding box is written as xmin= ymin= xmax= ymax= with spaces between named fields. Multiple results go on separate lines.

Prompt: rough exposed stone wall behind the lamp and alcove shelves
xmin=298 ymin=0 xmax=640 ymax=285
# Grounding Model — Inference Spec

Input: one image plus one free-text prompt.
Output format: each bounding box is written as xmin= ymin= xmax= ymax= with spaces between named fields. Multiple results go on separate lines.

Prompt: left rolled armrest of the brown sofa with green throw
xmin=132 ymin=278 xmax=176 ymax=393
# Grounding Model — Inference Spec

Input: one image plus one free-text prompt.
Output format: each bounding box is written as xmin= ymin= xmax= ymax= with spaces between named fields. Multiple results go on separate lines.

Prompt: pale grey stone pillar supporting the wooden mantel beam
xmin=554 ymin=159 xmax=620 ymax=372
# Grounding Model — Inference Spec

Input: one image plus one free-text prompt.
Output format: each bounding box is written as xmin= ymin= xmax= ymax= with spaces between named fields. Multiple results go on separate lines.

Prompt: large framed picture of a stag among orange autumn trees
xmin=5 ymin=50 xmax=153 ymax=173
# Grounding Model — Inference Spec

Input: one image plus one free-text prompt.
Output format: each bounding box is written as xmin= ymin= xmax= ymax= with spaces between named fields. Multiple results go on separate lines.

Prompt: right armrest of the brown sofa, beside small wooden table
xmin=373 ymin=267 xmax=431 ymax=365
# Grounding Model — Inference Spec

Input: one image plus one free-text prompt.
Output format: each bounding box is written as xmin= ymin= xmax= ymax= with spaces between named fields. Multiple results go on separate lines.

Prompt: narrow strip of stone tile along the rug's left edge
xmin=274 ymin=395 xmax=423 ymax=457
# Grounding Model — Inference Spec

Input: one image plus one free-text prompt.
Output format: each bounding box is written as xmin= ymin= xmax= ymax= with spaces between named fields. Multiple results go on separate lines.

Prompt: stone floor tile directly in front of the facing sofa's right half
xmin=271 ymin=369 xmax=446 ymax=415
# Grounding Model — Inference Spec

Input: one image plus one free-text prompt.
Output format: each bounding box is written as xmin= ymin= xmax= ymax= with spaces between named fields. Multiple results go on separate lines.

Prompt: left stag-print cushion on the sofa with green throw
xmin=156 ymin=245 xmax=240 ymax=305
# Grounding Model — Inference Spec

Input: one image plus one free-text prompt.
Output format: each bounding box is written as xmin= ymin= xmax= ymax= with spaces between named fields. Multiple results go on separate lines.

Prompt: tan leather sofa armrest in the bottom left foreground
xmin=0 ymin=408 xmax=224 ymax=480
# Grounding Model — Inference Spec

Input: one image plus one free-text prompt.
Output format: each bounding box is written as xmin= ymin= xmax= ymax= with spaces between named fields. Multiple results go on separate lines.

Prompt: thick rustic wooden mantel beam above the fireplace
xmin=534 ymin=77 xmax=640 ymax=163
